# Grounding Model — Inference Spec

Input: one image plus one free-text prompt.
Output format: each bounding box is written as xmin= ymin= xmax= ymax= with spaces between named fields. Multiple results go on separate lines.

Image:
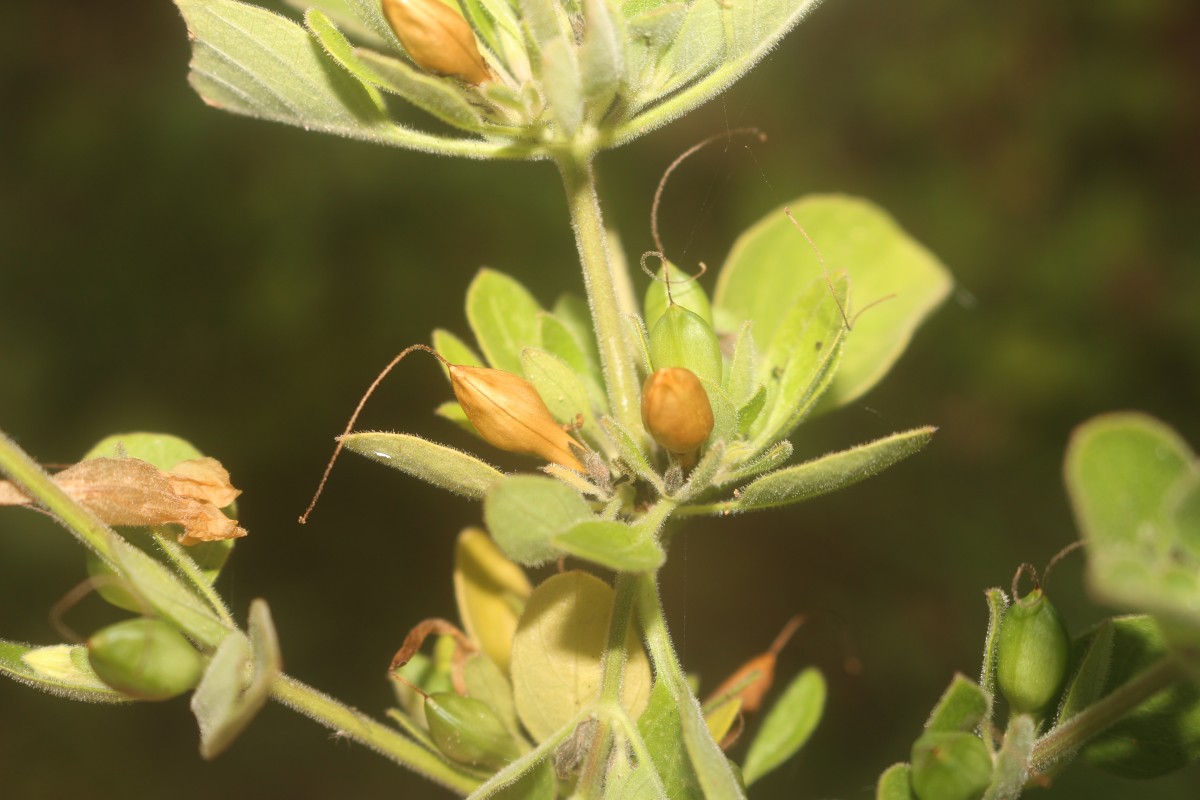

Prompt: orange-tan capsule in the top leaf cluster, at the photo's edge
xmin=383 ymin=0 xmax=492 ymax=84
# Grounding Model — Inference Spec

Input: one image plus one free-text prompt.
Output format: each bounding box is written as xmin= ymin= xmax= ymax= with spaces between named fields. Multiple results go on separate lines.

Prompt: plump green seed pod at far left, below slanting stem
xmin=88 ymin=618 xmax=204 ymax=700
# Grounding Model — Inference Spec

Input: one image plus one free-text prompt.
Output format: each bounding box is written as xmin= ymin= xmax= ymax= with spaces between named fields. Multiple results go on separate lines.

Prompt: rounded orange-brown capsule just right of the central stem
xmin=642 ymin=367 xmax=713 ymax=456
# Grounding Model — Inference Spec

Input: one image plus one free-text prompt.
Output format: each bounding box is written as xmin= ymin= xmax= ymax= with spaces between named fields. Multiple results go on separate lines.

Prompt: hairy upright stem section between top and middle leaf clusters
xmin=556 ymin=151 xmax=642 ymax=435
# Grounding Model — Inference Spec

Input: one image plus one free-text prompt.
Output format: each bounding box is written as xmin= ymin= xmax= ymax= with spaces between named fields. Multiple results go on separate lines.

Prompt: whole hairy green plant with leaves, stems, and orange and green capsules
xmin=0 ymin=0 xmax=1200 ymax=800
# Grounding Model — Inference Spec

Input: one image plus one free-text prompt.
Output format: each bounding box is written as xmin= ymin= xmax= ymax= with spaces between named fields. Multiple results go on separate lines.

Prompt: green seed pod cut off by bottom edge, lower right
xmin=911 ymin=730 xmax=991 ymax=800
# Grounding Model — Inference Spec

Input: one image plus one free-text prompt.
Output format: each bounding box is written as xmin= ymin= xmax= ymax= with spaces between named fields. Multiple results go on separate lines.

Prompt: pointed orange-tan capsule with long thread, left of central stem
xmin=448 ymin=363 xmax=585 ymax=473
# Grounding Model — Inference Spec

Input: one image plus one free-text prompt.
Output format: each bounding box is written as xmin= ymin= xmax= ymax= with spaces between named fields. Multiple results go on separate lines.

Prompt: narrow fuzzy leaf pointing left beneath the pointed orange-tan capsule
xmin=340 ymin=432 xmax=504 ymax=500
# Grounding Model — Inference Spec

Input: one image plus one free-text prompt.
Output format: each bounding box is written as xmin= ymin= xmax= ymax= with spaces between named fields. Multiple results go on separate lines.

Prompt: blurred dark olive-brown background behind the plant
xmin=0 ymin=0 xmax=1200 ymax=800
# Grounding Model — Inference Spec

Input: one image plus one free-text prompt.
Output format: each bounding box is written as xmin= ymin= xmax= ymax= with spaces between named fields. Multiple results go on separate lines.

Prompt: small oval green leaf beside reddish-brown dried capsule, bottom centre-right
xmin=743 ymin=667 xmax=826 ymax=786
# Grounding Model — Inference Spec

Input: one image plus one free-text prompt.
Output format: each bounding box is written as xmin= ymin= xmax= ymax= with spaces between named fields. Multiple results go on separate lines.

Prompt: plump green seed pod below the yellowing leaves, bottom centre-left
xmin=425 ymin=692 xmax=521 ymax=770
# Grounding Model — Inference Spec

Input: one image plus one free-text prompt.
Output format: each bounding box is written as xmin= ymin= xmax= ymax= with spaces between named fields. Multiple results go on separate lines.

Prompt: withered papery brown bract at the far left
xmin=0 ymin=458 xmax=246 ymax=545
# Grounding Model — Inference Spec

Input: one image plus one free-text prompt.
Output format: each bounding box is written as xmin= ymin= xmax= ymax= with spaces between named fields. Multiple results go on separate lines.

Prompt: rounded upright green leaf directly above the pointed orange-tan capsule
xmin=467 ymin=269 xmax=541 ymax=375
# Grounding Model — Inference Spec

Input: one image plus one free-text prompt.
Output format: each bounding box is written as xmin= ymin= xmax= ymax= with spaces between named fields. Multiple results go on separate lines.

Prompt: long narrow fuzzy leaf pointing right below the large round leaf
xmin=731 ymin=427 xmax=936 ymax=511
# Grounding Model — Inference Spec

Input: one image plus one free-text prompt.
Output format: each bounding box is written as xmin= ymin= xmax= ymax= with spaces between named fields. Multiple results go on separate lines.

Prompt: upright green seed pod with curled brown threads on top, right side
xmin=996 ymin=589 xmax=1070 ymax=717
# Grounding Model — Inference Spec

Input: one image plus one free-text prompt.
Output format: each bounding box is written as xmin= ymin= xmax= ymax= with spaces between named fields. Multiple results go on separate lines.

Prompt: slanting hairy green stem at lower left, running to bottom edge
xmin=271 ymin=675 xmax=479 ymax=795
